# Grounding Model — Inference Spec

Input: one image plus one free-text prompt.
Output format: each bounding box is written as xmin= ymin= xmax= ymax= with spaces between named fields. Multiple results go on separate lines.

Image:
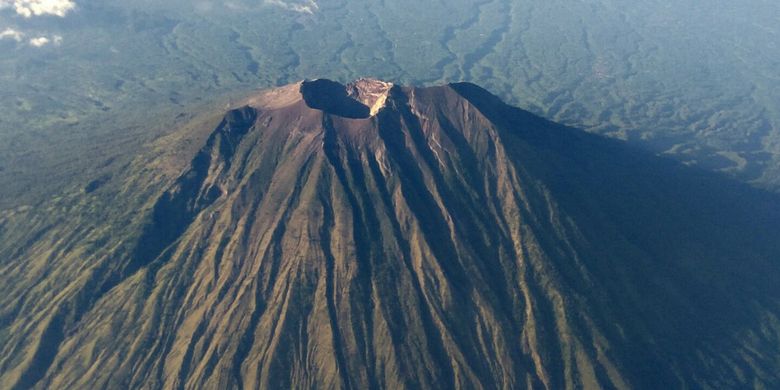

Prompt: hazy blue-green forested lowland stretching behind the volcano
xmin=0 ymin=0 xmax=780 ymax=207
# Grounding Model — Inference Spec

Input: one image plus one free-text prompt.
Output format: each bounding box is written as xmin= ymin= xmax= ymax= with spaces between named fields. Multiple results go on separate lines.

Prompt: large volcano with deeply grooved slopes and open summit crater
xmin=0 ymin=80 xmax=780 ymax=389
